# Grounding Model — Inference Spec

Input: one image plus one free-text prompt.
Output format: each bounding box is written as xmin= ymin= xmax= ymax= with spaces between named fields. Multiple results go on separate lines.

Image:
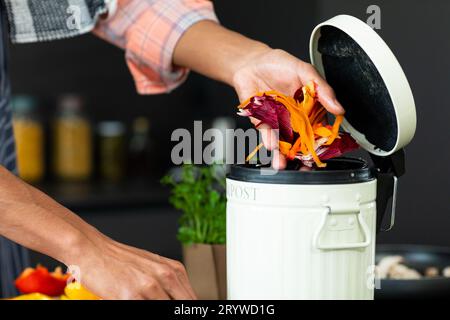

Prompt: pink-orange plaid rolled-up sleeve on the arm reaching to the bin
xmin=94 ymin=0 xmax=217 ymax=94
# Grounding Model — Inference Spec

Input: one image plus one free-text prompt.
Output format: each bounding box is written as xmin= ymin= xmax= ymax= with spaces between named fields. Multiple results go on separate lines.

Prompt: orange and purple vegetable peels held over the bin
xmin=238 ymin=82 xmax=358 ymax=167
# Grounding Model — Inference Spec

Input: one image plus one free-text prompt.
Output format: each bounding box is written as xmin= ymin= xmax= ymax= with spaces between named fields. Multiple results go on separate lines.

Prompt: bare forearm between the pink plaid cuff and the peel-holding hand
xmin=173 ymin=21 xmax=269 ymax=85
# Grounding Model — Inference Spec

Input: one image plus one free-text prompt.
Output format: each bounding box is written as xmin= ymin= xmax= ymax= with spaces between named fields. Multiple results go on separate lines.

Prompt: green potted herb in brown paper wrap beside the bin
xmin=162 ymin=164 xmax=226 ymax=299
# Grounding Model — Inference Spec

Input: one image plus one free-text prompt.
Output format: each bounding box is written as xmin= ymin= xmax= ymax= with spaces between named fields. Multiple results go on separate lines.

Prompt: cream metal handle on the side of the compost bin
xmin=313 ymin=207 xmax=371 ymax=250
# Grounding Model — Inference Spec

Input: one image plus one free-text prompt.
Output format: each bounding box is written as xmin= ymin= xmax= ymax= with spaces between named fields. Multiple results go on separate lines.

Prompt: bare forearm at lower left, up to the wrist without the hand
xmin=0 ymin=168 xmax=100 ymax=264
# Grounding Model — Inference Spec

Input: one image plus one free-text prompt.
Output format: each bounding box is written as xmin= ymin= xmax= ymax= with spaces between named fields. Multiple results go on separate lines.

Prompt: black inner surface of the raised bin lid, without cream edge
xmin=318 ymin=26 xmax=398 ymax=151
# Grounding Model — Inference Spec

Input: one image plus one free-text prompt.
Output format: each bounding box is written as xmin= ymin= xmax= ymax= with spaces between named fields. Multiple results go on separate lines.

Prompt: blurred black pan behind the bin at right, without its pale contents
xmin=375 ymin=245 xmax=450 ymax=299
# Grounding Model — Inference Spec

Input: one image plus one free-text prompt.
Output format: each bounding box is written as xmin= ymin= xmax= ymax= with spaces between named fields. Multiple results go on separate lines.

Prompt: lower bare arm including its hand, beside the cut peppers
xmin=0 ymin=167 xmax=195 ymax=299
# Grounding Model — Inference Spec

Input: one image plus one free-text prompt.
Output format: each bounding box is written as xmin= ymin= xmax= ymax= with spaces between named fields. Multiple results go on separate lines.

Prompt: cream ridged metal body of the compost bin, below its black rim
xmin=227 ymin=179 xmax=376 ymax=299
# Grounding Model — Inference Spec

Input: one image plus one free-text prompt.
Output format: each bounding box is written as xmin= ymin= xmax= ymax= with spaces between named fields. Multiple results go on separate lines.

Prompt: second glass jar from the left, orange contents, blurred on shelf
xmin=53 ymin=95 xmax=93 ymax=181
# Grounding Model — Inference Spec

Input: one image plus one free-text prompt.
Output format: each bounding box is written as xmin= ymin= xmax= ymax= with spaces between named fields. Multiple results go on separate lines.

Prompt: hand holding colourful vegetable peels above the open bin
xmin=233 ymin=46 xmax=344 ymax=169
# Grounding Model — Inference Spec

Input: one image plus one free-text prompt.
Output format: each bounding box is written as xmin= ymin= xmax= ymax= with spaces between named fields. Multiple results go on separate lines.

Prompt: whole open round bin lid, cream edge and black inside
xmin=310 ymin=15 xmax=416 ymax=157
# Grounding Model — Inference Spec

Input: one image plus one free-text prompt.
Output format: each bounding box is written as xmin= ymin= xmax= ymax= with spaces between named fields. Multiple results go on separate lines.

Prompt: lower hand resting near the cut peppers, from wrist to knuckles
xmin=72 ymin=237 xmax=196 ymax=300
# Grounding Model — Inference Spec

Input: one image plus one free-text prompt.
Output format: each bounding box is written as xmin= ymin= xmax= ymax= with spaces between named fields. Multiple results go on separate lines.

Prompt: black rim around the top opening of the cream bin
xmin=227 ymin=157 xmax=375 ymax=185
